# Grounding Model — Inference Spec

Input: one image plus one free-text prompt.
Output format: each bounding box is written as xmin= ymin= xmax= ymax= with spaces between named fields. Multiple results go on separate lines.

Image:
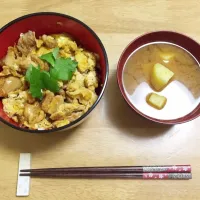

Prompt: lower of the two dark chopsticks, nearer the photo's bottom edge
xmin=20 ymin=172 xmax=192 ymax=180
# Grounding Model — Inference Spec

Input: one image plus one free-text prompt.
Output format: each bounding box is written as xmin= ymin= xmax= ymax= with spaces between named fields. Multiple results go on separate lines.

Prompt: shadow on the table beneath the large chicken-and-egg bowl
xmin=0 ymin=123 xmax=81 ymax=153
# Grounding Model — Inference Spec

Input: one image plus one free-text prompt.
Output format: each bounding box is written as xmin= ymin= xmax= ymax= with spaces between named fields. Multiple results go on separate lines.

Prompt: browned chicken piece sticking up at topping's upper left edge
xmin=17 ymin=31 xmax=36 ymax=56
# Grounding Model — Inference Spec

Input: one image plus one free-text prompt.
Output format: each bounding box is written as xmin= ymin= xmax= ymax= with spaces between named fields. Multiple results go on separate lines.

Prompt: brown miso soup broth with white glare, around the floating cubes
xmin=123 ymin=42 xmax=200 ymax=120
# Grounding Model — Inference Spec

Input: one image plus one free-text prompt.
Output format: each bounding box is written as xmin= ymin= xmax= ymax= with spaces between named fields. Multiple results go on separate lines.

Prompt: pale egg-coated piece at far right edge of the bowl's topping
xmin=85 ymin=71 xmax=98 ymax=91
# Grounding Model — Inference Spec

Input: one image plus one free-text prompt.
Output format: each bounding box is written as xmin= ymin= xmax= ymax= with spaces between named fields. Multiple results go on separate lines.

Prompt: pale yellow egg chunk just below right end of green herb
xmin=66 ymin=70 xmax=85 ymax=91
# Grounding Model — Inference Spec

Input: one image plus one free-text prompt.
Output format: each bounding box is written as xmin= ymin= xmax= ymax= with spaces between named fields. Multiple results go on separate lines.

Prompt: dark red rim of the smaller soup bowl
xmin=117 ymin=30 xmax=200 ymax=125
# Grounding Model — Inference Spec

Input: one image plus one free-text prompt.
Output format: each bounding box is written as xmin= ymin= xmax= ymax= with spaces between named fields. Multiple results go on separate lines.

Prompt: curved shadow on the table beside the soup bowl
xmin=105 ymin=67 xmax=173 ymax=137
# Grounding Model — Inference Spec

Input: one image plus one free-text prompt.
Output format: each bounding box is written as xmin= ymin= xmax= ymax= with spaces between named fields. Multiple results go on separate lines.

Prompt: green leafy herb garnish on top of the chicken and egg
xmin=25 ymin=48 xmax=78 ymax=99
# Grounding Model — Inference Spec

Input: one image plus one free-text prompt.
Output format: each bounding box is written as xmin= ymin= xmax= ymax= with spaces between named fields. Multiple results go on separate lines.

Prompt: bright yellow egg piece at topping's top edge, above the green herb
xmin=52 ymin=34 xmax=77 ymax=52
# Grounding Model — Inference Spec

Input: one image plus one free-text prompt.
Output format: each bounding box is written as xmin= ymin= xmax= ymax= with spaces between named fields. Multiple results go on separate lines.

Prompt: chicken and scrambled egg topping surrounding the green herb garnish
xmin=0 ymin=31 xmax=98 ymax=130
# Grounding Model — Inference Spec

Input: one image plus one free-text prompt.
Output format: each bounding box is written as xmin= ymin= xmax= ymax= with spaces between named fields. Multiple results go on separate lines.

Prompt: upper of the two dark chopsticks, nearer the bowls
xmin=20 ymin=165 xmax=191 ymax=173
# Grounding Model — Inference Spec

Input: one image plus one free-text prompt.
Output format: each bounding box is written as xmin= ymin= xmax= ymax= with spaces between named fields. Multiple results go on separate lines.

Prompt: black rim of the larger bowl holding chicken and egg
xmin=0 ymin=12 xmax=109 ymax=133
